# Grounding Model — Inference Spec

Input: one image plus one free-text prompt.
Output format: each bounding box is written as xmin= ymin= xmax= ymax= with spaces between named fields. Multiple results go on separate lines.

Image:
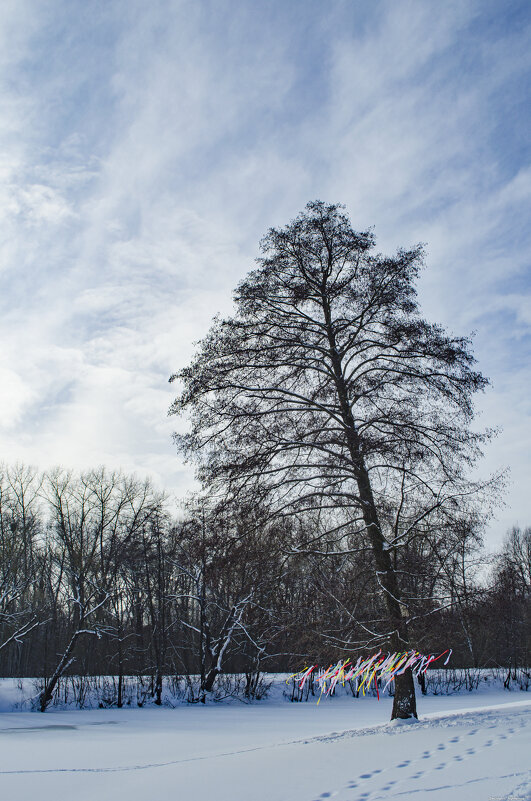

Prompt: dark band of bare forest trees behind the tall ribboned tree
xmin=0 ymin=465 xmax=531 ymax=709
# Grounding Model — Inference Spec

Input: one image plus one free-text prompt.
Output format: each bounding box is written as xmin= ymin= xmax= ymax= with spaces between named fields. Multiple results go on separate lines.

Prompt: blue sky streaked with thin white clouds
xmin=0 ymin=0 xmax=531 ymax=547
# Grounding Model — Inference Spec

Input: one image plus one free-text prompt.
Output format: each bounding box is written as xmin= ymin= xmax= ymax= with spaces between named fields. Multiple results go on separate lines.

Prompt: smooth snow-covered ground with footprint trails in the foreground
xmin=0 ymin=690 xmax=531 ymax=801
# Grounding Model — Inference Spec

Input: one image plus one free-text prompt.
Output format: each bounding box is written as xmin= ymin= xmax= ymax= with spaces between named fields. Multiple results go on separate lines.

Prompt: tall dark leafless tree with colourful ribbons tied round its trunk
xmin=170 ymin=201 xmax=498 ymax=718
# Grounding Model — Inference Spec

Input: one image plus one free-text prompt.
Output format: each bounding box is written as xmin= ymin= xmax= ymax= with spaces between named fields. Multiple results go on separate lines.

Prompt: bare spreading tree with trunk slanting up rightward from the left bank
xmin=39 ymin=469 xmax=163 ymax=712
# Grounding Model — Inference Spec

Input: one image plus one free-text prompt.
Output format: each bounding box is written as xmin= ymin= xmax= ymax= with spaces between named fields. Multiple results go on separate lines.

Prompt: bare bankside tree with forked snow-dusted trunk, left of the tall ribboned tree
xmin=174 ymin=499 xmax=282 ymax=702
